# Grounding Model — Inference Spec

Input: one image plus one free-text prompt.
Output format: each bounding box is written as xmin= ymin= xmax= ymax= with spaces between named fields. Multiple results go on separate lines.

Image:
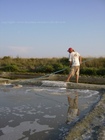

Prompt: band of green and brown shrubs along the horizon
xmin=0 ymin=56 xmax=105 ymax=76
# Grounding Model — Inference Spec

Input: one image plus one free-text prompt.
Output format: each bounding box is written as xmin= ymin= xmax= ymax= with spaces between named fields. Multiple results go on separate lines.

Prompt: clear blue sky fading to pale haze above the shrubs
xmin=0 ymin=0 xmax=105 ymax=58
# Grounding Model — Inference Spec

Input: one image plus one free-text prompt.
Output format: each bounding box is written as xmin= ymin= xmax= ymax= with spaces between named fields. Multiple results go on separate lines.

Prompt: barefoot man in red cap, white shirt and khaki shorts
xmin=66 ymin=48 xmax=82 ymax=83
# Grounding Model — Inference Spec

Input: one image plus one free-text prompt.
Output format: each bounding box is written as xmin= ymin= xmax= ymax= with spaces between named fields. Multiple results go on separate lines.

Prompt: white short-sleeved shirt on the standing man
xmin=69 ymin=52 xmax=80 ymax=66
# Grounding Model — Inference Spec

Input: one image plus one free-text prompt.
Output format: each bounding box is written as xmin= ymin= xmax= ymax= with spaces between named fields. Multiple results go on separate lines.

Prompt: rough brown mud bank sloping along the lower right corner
xmin=66 ymin=92 xmax=105 ymax=140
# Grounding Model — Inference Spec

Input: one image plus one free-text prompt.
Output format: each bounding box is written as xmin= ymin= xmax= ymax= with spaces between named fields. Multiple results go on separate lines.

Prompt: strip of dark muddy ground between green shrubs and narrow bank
xmin=0 ymin=72 xmax=105 ymax=85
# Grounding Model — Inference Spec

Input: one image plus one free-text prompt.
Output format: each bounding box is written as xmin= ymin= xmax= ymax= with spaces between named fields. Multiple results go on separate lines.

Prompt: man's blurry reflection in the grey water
xmin=66 ymin=93 xmax=79 ymax=124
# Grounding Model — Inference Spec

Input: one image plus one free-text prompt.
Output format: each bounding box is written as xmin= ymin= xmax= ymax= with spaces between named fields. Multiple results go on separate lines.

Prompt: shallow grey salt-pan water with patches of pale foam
xmin=0 ymin=84 xmax=100 ymax=140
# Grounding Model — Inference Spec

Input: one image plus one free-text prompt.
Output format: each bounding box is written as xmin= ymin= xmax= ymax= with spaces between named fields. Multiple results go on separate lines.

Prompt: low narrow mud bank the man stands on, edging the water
xmin=0 ymin=78 xmax=105 ymax=90
